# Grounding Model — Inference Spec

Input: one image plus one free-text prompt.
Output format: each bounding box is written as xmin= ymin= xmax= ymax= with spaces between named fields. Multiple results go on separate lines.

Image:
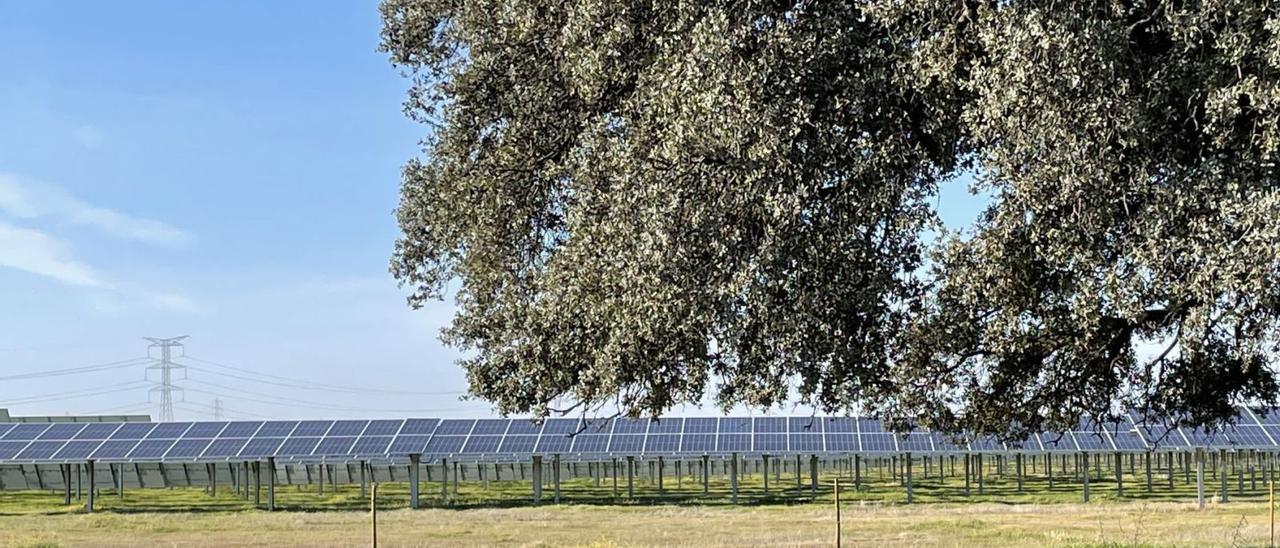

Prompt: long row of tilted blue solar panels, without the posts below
xmin=0 ymin=410 xmax=1280 ymax=462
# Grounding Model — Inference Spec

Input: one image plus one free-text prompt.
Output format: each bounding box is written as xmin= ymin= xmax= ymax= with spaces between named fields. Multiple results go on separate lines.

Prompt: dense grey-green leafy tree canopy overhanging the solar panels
xmin=381 ymin=0 xmax=1280 ymax=433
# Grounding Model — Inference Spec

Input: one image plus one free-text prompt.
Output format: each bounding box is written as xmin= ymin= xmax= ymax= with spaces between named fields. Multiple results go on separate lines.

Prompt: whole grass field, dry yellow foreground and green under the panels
xmin=0 ymin=463 xmax=1268 ymax=547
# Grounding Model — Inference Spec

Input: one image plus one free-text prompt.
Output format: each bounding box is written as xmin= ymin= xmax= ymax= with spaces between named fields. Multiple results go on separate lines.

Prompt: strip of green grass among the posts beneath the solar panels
xmin=0 ymin=460 xmax=1266 ymax=515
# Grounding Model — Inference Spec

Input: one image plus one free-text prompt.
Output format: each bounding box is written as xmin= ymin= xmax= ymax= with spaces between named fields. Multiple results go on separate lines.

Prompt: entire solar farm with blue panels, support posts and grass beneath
xmin=0 ymin=407 xmax=1280 ymax=544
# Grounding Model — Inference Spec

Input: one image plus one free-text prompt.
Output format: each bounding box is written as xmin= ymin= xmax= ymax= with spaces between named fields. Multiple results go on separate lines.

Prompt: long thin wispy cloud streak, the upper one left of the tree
xmin=0 ymin=173 xmax=192 ymax=245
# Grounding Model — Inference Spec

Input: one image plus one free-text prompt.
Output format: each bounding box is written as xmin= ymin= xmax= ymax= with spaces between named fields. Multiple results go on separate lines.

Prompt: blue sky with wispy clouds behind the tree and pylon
xmin=0 ymin=0 xmax=979 ymax=419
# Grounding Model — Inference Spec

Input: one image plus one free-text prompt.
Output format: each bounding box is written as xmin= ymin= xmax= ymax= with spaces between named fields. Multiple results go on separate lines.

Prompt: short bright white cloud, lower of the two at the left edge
xmin=0 ymin=218 xmax=111 ymax=288
